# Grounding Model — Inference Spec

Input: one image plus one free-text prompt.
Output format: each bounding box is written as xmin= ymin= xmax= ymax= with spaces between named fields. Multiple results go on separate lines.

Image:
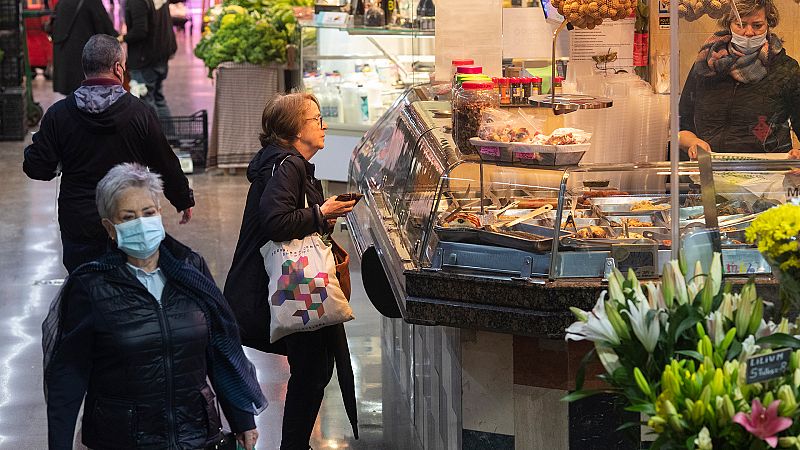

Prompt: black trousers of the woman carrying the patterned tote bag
xmin=281 ymin=327 xmax=334 ymax=450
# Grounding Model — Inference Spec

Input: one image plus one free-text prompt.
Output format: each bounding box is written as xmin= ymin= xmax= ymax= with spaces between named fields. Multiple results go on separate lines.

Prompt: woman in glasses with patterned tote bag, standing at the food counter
xmin=227 ymin=93 xmax=357 ymax=450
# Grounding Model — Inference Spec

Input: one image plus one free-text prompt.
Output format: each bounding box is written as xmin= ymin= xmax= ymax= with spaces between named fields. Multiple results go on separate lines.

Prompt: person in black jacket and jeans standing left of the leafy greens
xmin=119 ymin=0 xmax=178 ymax=117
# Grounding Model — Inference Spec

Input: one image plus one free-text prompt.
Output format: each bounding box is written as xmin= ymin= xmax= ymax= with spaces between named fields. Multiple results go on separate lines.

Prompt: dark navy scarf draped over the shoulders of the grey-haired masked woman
xmin=42 ymin=241 xmax=267 ymax=414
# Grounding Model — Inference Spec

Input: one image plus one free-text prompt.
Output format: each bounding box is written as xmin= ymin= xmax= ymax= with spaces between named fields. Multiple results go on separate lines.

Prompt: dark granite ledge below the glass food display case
xmin=404 ymin=270 xmax=778 ymax=339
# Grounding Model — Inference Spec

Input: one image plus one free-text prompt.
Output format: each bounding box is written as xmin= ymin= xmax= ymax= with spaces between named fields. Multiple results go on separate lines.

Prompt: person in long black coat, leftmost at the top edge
xmin=52 ymin=0 xmax=117 ymax=95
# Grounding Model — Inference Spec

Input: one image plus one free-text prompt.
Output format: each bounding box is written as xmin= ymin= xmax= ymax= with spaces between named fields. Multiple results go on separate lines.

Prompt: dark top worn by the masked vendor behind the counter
xmin=680 ymin=49 xmax=800 ymax=153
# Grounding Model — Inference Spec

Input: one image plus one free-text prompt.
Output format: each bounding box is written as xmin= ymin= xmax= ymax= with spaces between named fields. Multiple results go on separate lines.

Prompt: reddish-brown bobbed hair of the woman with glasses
xmin=258 ymin=92 xmax=319 ymax=147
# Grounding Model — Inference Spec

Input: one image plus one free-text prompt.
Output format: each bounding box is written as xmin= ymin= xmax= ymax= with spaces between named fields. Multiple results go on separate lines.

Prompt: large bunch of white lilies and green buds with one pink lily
xmin=565 ymin=253 xmax=800 ymax=450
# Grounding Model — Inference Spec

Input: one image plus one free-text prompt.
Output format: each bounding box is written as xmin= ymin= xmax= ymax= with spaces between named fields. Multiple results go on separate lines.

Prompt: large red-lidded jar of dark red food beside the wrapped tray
xmin=453 ymin=81 xmax=500 ymax=154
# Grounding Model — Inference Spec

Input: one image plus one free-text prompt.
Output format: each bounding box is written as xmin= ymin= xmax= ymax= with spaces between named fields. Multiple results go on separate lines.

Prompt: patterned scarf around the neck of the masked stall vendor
xmin=697 ymin=31 xmax=783 ymax=83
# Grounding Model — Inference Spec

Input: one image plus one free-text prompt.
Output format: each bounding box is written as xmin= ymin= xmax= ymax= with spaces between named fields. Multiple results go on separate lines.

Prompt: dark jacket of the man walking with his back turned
xmin=22 ymin=80 xmax=194 ymax=243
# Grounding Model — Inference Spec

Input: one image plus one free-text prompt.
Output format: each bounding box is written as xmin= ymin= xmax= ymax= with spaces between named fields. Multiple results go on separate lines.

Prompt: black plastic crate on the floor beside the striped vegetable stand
xmin=161 ymin=109 xmax=208 ymax=169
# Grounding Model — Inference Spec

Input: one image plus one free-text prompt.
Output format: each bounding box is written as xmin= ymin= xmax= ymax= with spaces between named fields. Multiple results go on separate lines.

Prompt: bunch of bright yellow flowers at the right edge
xmin=745 ymin=203 xmax=800 ymax=312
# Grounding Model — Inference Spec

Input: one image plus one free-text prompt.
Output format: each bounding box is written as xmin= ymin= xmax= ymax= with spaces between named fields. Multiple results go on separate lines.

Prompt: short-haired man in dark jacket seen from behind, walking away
xmin=22 ymin=35 xmax=194 ymax=272
